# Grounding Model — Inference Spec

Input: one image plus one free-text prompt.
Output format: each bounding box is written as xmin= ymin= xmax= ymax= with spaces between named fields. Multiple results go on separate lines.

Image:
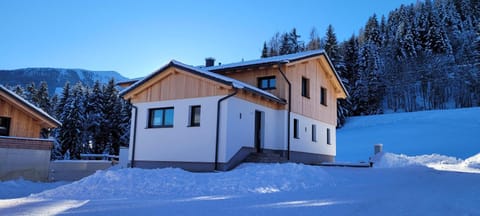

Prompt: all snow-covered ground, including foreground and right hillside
xmin=0 ymin=108 xmax=480 ymax=215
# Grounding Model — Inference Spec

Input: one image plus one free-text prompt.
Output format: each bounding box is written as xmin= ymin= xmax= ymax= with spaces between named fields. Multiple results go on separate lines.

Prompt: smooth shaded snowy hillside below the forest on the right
xmin=336 ymin=107 xmax=480 ymax=162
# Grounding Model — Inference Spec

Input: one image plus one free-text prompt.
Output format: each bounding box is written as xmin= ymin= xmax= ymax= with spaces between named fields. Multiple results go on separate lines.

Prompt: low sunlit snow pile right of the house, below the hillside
xmin=373 ymin=153 xmax=462 ymax=168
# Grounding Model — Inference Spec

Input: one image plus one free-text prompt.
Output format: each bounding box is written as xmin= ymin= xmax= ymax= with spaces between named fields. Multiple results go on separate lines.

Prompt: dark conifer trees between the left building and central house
xmin=10 ymin=79 xmax=131 ymax=159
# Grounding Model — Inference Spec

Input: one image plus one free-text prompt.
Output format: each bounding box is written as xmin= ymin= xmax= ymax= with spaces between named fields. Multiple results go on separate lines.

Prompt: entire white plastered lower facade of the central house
xmin=129 ymin=96 xmax=336 ymax=163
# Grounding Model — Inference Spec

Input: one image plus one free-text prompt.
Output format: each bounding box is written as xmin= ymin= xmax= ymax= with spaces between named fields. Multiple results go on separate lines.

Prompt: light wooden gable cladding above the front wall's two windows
xmin=128 ymin=67 xmax=231 ymax=103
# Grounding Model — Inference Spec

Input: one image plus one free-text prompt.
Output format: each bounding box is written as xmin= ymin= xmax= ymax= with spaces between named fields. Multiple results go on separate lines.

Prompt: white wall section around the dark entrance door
xmin=219 ymin=97 xmax=287 ymax=162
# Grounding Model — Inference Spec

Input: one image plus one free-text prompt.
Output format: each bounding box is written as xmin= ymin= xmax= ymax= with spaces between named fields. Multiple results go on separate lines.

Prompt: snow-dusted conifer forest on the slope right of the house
xmin=261 ymin=0 xmax=480 ymax=127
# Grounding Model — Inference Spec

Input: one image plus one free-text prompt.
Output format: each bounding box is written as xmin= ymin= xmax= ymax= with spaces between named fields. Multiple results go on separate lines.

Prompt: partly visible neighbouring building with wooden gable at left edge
xmin=0 ymin=85 xmax=61 ymax=181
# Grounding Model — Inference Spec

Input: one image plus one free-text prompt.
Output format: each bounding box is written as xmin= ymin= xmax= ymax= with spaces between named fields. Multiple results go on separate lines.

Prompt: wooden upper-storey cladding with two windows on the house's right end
xmin=286 ymin=58 xmax=337 ymax=125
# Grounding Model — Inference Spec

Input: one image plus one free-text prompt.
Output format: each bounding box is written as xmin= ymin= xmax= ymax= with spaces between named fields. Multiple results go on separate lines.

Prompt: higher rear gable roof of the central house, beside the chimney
xmin=203 ymin=49 xmax=349 ymax=97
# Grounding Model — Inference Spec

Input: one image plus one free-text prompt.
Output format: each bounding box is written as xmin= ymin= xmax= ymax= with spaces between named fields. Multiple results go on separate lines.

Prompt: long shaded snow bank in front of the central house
xmin=33 ymin=163 xmax=333 ymax=199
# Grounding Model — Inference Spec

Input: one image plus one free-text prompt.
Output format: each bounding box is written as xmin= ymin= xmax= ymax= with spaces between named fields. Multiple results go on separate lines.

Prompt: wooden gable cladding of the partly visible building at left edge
xmin=0 ymin=95 xmax=42 ymax=138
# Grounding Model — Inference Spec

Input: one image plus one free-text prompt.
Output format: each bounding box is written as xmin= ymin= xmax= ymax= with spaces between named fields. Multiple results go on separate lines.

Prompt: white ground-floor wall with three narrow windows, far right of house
xmin=290 ymin=112 xmax=337 ymax=156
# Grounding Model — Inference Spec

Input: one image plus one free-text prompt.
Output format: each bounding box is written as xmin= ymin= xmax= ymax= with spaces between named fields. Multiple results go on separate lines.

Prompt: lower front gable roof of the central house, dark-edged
xmin=120 ymin=60 xmax=286 ymax=104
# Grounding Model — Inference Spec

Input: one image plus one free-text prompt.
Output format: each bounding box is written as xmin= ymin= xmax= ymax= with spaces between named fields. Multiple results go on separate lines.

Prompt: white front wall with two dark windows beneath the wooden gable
xmin=129 ymin=96 xmax=221 ymax=162
